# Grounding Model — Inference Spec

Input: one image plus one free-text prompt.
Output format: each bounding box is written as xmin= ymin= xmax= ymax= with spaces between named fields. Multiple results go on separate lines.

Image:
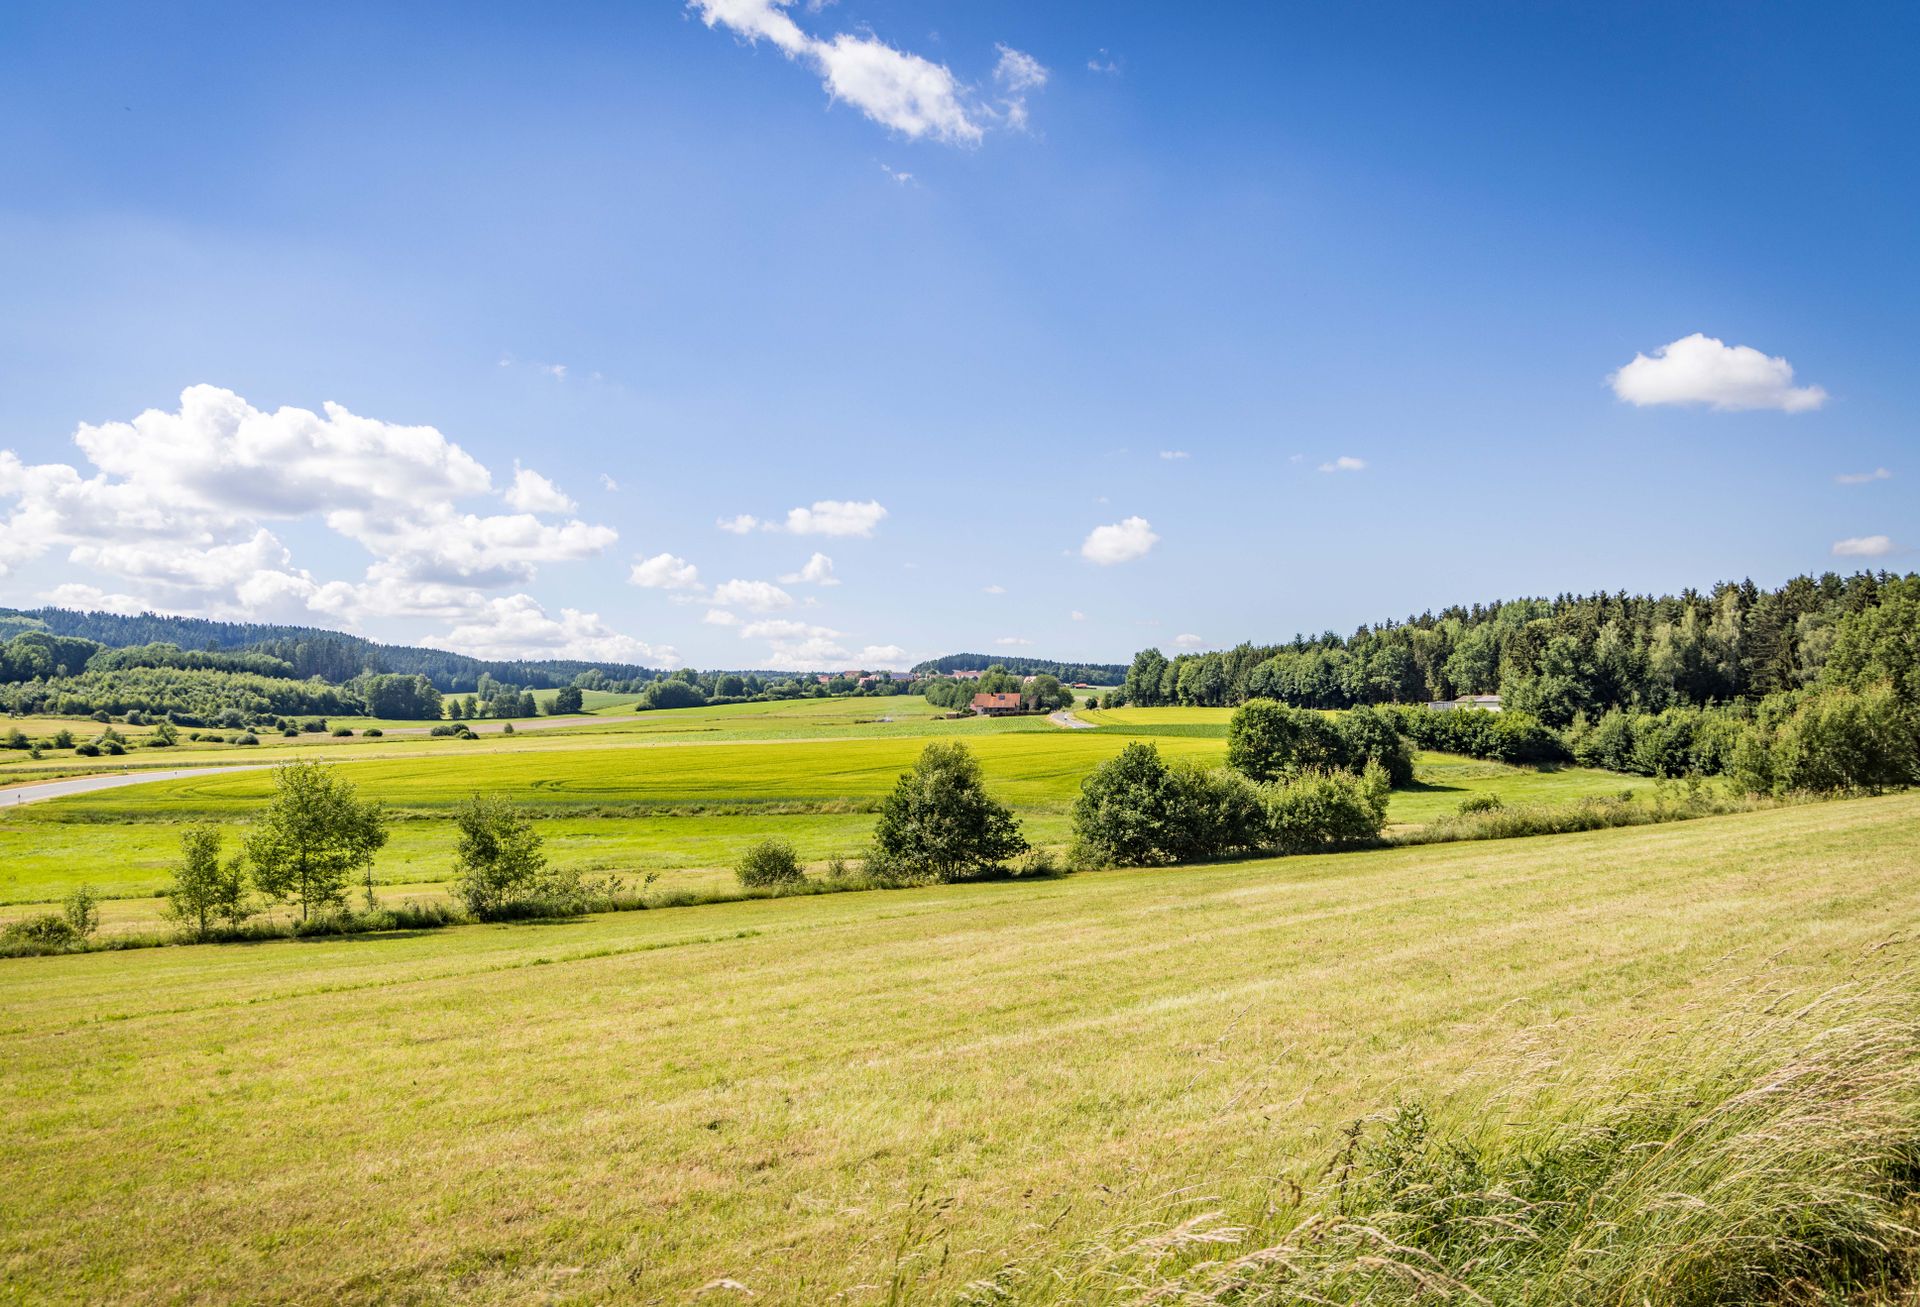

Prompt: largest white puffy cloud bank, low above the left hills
xmin=0 ymin=386 xmax=616 ymax=644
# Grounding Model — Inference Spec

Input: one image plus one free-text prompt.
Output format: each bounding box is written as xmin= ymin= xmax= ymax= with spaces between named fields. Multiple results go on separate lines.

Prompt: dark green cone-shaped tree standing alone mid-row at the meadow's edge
xmin=870 ymin=743 xmax=1027 ymax=881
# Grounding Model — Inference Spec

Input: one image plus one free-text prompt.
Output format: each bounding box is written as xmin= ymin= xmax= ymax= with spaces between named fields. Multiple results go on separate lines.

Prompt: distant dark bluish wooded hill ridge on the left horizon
xmin=0 ymin=608 xmax=664 ymax=693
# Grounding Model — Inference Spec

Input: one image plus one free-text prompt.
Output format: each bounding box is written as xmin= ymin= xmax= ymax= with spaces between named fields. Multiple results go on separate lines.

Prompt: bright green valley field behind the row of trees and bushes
xmin=0 ymin=697 xmax=1651 ymax=917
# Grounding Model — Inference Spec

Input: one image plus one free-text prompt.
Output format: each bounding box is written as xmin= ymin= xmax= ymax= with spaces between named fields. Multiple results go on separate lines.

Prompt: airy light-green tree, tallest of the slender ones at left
xmin=246 ymin=762 xmax=386 ymax=921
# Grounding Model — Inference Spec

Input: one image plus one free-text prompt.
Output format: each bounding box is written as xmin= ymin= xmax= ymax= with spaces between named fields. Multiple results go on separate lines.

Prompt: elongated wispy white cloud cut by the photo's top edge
xmin=689 ymin=0 xmax=985 ymax=144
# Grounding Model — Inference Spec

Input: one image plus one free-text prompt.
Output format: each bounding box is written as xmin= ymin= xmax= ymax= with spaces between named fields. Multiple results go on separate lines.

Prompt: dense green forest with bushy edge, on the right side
xmin=1110 ymin=572 xmax=1920 ymax=789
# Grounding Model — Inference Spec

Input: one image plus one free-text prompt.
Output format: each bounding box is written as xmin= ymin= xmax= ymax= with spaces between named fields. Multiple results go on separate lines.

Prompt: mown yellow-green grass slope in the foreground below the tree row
xmin=0 ymin=796 xmax=1920 ymax=1303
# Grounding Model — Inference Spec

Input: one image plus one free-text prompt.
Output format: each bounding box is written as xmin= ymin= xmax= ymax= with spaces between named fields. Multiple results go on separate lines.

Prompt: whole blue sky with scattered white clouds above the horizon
xmin=0 ymin=0 xmax=1920 ymax=666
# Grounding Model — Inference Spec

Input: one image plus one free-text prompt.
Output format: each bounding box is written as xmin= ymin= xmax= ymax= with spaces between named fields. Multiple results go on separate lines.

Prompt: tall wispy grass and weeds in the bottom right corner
xmin=998 ymin=973 xmax=1920 ymax=1307
